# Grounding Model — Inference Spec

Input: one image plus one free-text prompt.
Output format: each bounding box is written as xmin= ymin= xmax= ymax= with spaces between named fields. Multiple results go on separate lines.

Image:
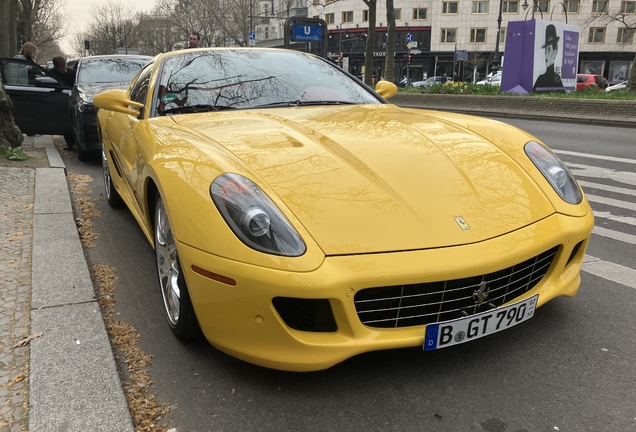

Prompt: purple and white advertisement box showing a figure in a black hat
xmin=501 ymin=20 xmax=580 ymax=93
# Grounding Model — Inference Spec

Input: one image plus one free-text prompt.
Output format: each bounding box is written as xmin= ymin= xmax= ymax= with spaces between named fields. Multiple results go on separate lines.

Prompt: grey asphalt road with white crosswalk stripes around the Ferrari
xmin=65 ymin=120 xmax=636 ymax=432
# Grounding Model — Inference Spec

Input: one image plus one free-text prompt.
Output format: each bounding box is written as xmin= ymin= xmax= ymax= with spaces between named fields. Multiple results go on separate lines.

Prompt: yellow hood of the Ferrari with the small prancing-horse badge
xmin=173 ymin=105 xmax=554 ymax=255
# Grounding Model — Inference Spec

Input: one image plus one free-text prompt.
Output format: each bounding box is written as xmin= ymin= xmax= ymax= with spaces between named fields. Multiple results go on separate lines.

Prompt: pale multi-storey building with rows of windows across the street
xmin=255 ymin=0 xmax=636 ymax=83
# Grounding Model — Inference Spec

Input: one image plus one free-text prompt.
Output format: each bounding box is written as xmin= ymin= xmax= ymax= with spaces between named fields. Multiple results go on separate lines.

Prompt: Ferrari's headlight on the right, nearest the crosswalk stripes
xmin=525 ymin=141 xmax=583 ymax=204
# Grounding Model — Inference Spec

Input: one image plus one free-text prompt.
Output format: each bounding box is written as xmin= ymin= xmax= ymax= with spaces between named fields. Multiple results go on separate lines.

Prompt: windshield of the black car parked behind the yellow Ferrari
xmin=77 ymin=58 xmax=148 ymax=83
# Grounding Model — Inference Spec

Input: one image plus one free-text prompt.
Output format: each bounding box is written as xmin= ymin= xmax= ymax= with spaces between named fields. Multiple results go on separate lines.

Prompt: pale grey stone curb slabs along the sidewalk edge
xmin=29 ymin=136 xmax=134 ymax=432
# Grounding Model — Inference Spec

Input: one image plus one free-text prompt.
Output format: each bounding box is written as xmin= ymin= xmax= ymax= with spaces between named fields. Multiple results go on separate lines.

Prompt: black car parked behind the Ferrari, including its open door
xmin=0 ymin=55 xmax=152 ymax=161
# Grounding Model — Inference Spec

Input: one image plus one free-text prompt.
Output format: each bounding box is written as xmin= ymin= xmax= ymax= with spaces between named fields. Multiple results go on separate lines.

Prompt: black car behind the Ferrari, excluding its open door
xmin=71 ymin=55 xmax=152 ymax=161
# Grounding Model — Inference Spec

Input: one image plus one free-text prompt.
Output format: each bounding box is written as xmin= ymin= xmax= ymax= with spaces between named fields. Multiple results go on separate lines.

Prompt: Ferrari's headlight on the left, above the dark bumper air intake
xmin=210 ymin=174 xmax=307 ymax=256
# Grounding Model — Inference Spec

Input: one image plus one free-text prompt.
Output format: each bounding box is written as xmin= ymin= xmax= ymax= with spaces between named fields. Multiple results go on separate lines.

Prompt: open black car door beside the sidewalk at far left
xmin=0 ymin=58 xmax=73 ymax=135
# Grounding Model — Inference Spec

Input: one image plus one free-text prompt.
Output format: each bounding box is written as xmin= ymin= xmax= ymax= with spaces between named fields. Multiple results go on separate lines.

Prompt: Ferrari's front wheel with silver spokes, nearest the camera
xmin=154 ymin=195 xmax=201 ymax=339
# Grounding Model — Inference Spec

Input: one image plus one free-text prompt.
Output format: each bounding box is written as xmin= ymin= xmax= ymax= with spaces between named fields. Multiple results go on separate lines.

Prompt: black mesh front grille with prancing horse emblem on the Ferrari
xmin=354 ymin=246 xmax=558 ymax=328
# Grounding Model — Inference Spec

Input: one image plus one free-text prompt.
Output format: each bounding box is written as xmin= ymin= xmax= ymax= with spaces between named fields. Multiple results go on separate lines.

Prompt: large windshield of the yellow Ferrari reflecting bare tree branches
xmin=156 ymin=49 xmax=381 ymax=115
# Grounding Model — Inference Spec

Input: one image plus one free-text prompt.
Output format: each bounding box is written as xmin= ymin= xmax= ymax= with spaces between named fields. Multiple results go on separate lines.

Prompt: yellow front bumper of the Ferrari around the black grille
xmin=177 ymin=212 xmax=594 ymax=371
